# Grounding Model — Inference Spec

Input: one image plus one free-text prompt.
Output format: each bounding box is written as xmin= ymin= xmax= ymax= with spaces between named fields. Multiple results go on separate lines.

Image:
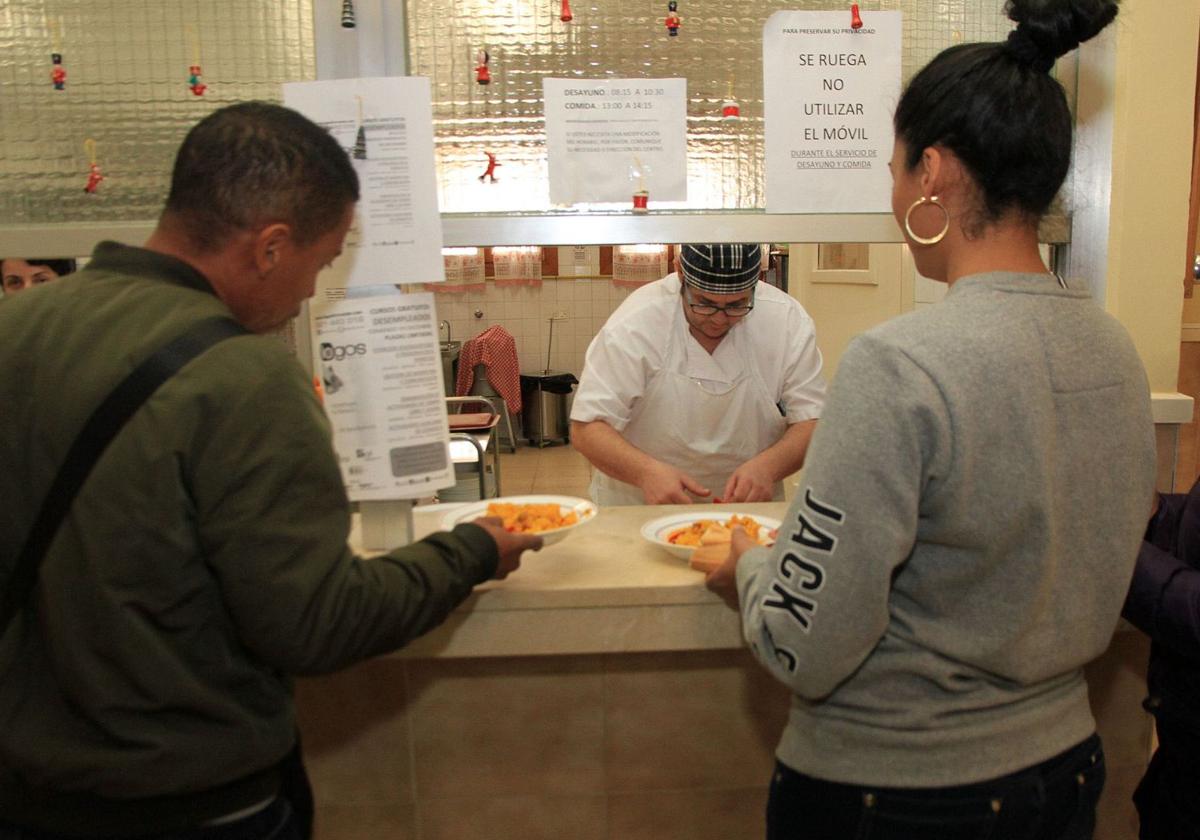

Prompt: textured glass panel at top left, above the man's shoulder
xmin=0 ymin=0 xmax=316 ymax=224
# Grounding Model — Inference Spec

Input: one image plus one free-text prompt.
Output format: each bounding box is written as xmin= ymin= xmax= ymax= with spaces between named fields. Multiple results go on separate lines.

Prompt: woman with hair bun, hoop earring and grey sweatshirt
xmin=708 ymin=0 xmax=1156 ymax=840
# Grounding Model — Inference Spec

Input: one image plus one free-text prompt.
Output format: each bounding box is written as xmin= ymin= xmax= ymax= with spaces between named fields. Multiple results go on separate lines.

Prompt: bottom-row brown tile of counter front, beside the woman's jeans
xmin=608 ymin=786 xmax=768 ymax=840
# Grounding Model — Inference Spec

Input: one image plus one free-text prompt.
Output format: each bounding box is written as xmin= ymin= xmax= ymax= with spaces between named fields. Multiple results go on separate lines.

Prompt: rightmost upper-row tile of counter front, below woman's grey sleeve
xmin=605 ymin=650 xmax=790 ymax=792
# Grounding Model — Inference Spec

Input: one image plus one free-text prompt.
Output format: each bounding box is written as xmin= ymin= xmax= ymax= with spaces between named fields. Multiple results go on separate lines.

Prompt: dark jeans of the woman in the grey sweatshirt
xmin=767 ymin=736 xmax=1104 ymax=840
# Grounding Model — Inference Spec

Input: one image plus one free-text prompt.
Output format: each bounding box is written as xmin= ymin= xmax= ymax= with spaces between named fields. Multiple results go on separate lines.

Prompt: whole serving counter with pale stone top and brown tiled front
xmin=296 ymin=503 xmax=1150 ymax=840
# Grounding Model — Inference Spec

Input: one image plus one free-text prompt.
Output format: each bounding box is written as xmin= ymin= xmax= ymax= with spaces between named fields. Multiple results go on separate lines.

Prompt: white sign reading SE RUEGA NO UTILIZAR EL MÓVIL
xmin=762 ymin=10 xmax=901 ymax=212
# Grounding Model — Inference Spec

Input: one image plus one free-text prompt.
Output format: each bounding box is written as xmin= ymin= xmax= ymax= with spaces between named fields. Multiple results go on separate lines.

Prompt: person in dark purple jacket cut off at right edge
xmin=1122 ymin=481 xmax=1200 ymax=840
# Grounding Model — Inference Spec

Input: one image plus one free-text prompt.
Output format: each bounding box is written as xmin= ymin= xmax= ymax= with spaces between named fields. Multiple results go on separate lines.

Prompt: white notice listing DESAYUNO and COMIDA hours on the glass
xmin=542 ymin=79 xmax=688 ymax=204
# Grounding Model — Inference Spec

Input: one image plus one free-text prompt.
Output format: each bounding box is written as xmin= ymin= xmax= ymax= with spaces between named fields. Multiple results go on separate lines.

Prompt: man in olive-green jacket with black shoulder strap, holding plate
xmin=0 ymin=103 xmax=541 ymax=840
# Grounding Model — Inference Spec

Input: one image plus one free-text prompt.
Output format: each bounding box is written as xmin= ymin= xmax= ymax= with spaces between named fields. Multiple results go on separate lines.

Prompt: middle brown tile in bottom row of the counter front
xmin=420 ymin=796 xmax=607 ymax=840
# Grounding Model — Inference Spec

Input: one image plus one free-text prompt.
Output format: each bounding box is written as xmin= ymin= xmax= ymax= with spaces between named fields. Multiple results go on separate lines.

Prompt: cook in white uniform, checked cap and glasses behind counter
xmin=571 ymin=244 xmax=824 ymax=505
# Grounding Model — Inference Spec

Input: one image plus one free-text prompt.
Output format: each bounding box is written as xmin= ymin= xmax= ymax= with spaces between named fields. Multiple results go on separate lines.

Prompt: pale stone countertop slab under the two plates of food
xmin=379 ymin=502 xmax=787 ymax=658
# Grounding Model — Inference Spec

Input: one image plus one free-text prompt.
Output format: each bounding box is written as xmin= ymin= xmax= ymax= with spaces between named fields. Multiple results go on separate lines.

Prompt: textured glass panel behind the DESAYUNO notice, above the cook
xmin=407 ymin=0 xmax=1027 ymax=212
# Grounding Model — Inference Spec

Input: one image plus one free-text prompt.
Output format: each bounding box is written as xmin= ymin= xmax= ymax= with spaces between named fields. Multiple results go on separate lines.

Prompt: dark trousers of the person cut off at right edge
xmin=1133 ymin=722 xmax=1200 ymax=840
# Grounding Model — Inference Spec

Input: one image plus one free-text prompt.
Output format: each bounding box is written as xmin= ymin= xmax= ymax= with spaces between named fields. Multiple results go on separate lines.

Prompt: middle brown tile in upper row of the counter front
xmin=409 ymin=656 xmax=604 ymax=799
